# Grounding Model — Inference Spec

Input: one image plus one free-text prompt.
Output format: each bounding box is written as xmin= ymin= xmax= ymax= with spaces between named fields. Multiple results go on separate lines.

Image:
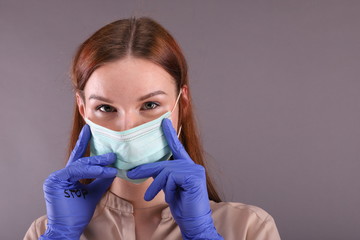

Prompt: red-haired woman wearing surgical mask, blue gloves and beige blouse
xmin=25 ymin=18 xmax=280 ymax=240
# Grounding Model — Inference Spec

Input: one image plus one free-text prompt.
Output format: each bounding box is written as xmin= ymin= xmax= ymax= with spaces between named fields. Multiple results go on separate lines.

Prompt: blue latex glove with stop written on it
xmin=39 ymin=125 xmax=117 ymax=240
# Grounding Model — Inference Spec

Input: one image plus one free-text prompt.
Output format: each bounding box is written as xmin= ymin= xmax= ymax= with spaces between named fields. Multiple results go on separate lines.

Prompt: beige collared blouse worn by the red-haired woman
xmin=24 ymin=191 xmax=280 ymax=240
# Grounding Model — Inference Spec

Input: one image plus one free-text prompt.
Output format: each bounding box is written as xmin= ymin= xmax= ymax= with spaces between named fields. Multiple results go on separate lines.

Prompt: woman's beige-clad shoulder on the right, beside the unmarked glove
xmin=210 ymin=201 xmax=280 ymax=239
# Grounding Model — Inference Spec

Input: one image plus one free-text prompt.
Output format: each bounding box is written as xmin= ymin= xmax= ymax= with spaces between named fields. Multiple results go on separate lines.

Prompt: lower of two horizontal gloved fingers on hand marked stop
xmin=53 ymin=165 xmax=117 ymax=182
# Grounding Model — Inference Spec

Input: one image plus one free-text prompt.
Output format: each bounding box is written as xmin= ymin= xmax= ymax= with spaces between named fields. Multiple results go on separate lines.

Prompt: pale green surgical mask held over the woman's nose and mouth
xmin=85 ymin=91 xmax=181 ymax=183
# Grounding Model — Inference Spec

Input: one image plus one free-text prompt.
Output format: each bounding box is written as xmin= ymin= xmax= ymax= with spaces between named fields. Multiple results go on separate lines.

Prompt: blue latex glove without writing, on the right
xmin=127 ymin=119 xmax=223 ymax=240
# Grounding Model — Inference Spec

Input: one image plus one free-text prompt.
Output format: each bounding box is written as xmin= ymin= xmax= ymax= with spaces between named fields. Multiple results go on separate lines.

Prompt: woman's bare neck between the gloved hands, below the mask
xmin=110 ymin=177 xmax=166 ymax=209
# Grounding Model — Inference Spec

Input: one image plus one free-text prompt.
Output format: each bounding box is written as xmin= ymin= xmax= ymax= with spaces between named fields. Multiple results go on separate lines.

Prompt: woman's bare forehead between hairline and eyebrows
xmin=84 ymin=57 xmax=176 ymax=99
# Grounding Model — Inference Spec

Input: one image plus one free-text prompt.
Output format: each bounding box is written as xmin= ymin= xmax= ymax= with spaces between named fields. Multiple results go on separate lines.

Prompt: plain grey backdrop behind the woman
xmin=0 ymin=0 xmax=360 ymax=240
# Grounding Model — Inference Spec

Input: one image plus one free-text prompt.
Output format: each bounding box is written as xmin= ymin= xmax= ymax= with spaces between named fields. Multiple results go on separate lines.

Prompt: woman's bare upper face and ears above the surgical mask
xmin=76 ymin=57 xmax=187 ymax=131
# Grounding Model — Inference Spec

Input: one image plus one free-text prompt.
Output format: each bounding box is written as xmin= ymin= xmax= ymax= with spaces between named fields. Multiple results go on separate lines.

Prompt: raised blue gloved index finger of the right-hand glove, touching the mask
xmin=161 ymin=118 xmax=191 ymax=159
